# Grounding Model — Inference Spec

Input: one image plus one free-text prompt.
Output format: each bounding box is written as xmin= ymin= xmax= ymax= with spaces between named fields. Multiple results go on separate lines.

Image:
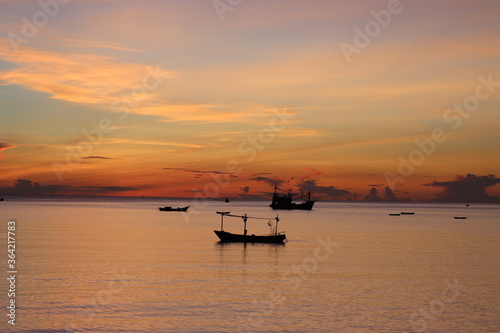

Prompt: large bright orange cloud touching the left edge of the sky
xmin=0 ymin=39 xmax=173 ymax=106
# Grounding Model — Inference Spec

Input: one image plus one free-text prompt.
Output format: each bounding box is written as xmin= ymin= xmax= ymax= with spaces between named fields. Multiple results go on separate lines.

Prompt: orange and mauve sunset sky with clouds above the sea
xmin=0 ymin=0 xmax=500 ymax=202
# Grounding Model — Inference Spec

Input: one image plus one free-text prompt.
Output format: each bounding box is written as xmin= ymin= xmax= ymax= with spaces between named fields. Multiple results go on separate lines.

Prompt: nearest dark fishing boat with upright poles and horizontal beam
xmin=214 ymin=212 xmax=286 ymax=244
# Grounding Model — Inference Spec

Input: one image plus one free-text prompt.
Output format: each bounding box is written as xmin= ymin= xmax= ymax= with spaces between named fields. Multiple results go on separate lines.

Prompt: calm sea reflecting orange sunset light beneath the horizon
xmin=0 ymin=197 xmax=500 ymax=333
